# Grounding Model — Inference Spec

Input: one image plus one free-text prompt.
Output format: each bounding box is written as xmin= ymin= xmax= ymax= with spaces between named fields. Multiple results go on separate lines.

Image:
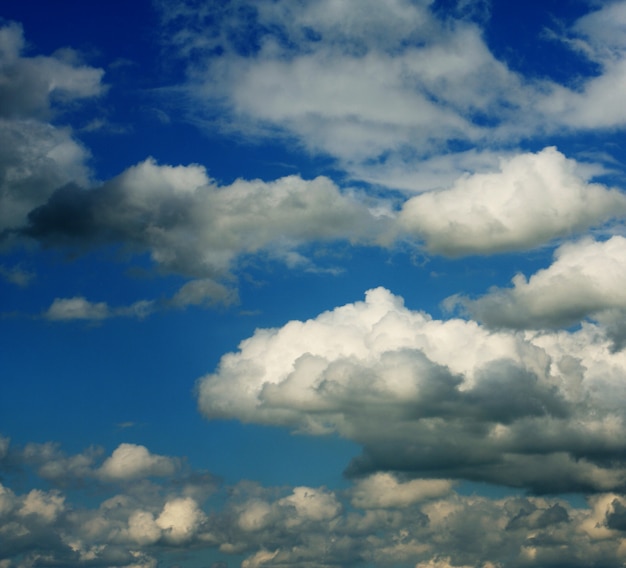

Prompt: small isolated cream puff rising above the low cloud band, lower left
xmin=97 ymin=444 xmax=179 ymax=481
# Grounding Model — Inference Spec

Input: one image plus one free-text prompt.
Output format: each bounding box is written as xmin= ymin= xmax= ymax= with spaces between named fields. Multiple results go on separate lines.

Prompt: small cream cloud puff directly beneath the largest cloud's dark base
xmin=352 ymin=472 xmax=452 ymax=509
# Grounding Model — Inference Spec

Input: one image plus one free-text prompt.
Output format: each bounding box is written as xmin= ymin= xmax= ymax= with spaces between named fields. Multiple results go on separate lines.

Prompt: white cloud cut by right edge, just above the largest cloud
xmin=449 ymin=236 xmax=626 ymax=328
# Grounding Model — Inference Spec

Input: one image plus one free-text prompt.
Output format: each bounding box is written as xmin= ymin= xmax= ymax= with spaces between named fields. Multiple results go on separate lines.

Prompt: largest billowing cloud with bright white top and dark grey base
xmin=198 ymin=288 xmax=626 ymax=492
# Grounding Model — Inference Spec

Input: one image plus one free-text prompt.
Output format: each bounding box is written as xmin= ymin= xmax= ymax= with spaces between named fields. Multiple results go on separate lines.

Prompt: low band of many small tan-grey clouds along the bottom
xmin=6 ymin=438 xmax=626 ymax=568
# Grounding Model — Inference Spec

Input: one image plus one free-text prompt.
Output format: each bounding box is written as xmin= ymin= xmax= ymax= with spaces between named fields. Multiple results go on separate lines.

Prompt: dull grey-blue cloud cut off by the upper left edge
xmin=0 ymin=24 xmax=103 ymax=238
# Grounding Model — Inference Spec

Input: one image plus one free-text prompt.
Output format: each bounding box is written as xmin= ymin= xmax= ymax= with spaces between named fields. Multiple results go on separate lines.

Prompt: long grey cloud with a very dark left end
xmin=23 ymin=159 xmax=384 ymax=278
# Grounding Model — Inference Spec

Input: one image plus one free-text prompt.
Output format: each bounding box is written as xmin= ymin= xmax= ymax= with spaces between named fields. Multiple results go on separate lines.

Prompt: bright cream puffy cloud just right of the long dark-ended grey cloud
xmin=398 ymin=148 xmax=626 ymax=256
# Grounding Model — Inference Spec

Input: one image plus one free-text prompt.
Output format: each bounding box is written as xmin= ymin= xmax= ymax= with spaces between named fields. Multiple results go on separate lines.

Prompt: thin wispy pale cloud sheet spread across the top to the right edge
xmin=159 ymin=0 xmax=626 ymax=189
